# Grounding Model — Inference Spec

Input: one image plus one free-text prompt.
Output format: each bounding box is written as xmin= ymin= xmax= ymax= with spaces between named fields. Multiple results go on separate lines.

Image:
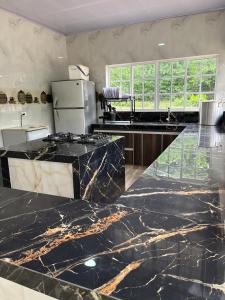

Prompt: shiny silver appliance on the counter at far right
xmin=199 ymin=100 xmax=223 ymax=126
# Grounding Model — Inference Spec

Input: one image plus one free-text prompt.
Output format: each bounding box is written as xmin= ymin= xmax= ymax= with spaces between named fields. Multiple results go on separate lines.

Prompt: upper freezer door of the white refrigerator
xmin=52 ymin=80 xmax=88 ymax=109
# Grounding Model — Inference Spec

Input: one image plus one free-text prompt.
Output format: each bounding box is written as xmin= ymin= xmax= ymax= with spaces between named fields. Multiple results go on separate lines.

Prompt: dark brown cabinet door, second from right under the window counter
xmin=143 ymin=134 xmax=162 ymax=166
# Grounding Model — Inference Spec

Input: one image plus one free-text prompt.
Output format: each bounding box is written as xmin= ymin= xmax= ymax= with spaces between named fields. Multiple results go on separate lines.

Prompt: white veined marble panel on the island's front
xmin=8 ymin=158 xmax=74 ymax=198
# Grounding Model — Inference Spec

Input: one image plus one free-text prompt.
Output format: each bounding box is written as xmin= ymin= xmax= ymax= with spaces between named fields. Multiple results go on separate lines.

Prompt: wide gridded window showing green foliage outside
xmin=107 ymin=56 xmax=217 ymax=110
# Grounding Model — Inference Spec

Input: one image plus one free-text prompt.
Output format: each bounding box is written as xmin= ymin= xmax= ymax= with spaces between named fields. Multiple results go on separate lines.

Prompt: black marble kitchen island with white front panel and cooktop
xmin=0 ymin=136 xmax=125 ymax=202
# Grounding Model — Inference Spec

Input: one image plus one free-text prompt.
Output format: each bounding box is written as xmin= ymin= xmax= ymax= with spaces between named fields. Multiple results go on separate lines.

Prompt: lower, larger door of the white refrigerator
xmin=54 ymin=108 xmax=87 ymax=134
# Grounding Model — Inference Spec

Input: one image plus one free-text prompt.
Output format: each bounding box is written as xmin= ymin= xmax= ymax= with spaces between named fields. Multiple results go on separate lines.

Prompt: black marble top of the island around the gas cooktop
xmin=0 ymin=136 xmax=121 ymax=162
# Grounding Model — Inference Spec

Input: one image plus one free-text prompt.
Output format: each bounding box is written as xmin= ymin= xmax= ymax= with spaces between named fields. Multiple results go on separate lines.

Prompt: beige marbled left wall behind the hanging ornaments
xmin=0 ymin=10 xmax=67 ymax=146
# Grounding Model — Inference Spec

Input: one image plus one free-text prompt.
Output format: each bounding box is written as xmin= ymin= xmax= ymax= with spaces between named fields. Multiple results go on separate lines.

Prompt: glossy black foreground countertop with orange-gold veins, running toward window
xmin=0 ymin=125 xmax=225 ymax=300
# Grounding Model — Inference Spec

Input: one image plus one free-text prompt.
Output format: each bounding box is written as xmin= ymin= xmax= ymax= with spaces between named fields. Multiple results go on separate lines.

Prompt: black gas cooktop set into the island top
xmin=43 ymin=132 xmax=109 ymax=145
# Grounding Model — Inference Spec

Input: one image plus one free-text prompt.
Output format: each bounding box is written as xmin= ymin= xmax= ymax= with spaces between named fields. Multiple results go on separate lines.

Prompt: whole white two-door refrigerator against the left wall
xmin=52 ymin=80 xmax=96 ymax=134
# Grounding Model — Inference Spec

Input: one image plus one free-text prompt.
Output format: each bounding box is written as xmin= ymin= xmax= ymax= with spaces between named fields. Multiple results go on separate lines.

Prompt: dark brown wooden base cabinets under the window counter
xmin=94 ymin=129 xmax=178 ymax=167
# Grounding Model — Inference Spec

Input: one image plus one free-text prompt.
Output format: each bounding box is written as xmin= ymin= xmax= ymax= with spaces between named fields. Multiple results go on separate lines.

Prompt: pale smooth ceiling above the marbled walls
xmin=0 ymin=0 xmax=225 ymax=34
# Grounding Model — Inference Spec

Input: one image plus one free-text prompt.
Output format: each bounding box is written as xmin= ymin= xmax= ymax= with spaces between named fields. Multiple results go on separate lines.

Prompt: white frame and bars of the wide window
xmin=105 ymin=54 xmax=219 ymax=112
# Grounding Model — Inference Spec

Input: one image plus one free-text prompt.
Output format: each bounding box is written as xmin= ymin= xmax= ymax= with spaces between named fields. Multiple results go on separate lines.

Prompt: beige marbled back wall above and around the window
xmin=67 ymin=10 xmax=225 ymax=97
